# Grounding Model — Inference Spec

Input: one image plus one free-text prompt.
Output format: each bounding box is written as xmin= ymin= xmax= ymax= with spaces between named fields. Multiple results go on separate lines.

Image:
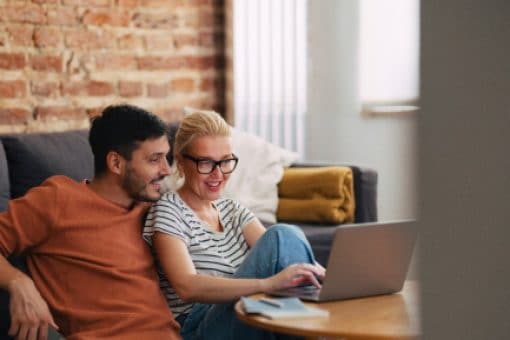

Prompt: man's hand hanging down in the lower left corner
xmin=8 ymin=273 xmax=58 ymax=340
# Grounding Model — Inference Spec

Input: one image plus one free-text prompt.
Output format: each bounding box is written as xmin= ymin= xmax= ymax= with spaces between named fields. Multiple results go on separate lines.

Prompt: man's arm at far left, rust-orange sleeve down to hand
xmin=0 ymin=185 xmax=58 ymax=340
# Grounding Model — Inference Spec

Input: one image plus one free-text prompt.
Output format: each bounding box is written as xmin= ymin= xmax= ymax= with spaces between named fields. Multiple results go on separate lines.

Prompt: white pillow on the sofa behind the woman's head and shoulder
xmin=223 ymin=128 xmax=298 ymax=223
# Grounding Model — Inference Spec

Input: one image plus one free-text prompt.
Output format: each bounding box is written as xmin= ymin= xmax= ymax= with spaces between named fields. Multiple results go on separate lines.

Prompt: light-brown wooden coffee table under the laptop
xmin=235 ymin=281 xmax=420 ymax=340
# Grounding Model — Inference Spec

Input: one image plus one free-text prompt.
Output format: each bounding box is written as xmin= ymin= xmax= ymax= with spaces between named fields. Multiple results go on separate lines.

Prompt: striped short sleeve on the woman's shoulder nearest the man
xmin=143 ymin=196 xmax=191 ymax=246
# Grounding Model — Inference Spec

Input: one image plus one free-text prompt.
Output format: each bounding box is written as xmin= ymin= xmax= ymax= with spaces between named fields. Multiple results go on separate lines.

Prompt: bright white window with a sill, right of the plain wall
xmin=360 ymin=0 xmax=419 ymax=114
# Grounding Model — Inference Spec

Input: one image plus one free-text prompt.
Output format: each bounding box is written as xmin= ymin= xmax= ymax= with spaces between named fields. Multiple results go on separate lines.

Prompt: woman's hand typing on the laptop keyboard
xmin=267 ymin=263 xmax=325 ymax=291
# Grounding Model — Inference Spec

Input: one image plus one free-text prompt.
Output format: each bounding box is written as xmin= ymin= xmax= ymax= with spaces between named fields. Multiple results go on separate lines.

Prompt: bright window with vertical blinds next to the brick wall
xmin=233 ymin=0 xmax=307 ymax=155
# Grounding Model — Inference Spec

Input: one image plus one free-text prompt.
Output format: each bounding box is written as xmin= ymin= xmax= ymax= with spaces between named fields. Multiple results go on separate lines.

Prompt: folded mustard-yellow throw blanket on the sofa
xmin=277 ymin=167 xmax=355 ymax=224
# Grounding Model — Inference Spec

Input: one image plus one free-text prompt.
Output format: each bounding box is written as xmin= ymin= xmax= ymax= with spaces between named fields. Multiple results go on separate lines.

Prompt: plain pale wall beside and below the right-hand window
xmin=305 ymin=0 xmax=416 ymax=220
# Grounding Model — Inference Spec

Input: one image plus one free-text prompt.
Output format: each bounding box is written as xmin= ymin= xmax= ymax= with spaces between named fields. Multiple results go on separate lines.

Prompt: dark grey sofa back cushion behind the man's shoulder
xmin=2 ymin=130 xmax=94 ymax=198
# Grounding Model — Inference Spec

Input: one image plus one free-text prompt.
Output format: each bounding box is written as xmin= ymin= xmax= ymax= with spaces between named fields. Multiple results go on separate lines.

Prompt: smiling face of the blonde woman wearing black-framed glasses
xmin=178 ymin=136 xmax=234 ymax=201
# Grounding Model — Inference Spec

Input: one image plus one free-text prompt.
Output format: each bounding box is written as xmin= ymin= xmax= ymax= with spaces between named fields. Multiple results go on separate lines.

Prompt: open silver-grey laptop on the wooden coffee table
xmin=270 ymin=221 xmax=417 ymax=302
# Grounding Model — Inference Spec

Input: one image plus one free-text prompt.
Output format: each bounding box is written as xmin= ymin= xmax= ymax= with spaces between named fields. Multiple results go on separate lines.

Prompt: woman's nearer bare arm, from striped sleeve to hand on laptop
xmin=153 ymin=232 xmax=320 ymax=303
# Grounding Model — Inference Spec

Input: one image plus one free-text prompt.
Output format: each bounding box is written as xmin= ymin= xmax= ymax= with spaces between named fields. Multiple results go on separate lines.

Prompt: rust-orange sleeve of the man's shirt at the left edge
xmin=0 ymin=181 xmax=58 ymax=257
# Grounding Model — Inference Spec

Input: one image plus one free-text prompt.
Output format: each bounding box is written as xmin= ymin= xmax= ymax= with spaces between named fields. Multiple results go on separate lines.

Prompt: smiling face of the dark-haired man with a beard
xmin=122 ymin=136 xmax=170 ymax=202
